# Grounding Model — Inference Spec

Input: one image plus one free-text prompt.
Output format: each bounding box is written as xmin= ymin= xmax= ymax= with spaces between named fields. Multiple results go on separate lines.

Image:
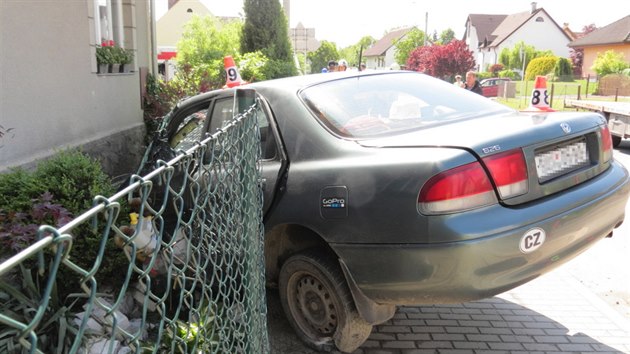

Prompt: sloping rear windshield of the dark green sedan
xmin=300 ymin=72 xmax=511 ymax=138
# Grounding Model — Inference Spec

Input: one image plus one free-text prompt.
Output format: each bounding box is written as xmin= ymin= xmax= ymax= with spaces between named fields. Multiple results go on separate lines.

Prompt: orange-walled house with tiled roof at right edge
xmin=569 ymin=15 xmax=630 ymax=76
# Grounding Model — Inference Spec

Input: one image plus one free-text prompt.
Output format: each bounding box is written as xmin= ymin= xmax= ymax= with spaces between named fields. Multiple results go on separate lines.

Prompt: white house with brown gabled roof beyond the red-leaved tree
xmin=464 ymin=2 xmax=572 ymax=71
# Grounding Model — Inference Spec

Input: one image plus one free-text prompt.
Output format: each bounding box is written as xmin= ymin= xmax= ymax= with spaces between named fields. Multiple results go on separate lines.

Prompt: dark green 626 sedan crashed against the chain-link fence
xmin=143 ymin=71 xmax=630 ymax=352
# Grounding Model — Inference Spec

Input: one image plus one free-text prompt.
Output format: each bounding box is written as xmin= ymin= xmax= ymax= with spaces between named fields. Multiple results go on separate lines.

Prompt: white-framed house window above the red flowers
xmin=92 ymin=0 xmax=125 ymax=47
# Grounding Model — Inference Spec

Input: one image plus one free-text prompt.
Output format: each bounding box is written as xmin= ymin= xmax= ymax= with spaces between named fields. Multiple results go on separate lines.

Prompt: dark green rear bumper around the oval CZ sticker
xmin=331 ymin=163 xmax=630 ymax=305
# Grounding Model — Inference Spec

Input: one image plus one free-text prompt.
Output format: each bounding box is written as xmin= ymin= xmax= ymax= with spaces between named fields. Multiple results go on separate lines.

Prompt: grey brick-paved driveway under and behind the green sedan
xmin=267 ymin=140 xmax=630 ymax=354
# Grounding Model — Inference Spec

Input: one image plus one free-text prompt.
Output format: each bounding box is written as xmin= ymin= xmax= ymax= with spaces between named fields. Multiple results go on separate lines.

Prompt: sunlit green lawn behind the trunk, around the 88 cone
xmin=496 ymin=80 xmax=630 ymax=111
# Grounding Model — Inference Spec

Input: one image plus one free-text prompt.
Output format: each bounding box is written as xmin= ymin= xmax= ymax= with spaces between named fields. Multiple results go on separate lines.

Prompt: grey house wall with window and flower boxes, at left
xmin=0 ymin=0 xmax=156 ymax=175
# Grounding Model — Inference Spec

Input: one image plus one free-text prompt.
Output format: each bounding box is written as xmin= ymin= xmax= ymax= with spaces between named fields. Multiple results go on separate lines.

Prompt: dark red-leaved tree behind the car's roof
xmin=407 ymin=40 xmax=475 ymax=80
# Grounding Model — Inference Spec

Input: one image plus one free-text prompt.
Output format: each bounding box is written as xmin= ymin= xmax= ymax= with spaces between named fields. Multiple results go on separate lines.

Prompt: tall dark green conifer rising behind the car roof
xmin=241 ymin=0 xmax=297 ymax=78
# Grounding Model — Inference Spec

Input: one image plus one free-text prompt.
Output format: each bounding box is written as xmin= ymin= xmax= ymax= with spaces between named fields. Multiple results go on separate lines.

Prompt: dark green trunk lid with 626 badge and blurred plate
xmin=359 ymin=112 xmax=612 ymax=205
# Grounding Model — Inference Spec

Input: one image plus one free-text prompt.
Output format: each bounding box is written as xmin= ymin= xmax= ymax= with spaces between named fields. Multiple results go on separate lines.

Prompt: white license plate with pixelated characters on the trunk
xmin=536 ymin=139 xmax=590 ymax=182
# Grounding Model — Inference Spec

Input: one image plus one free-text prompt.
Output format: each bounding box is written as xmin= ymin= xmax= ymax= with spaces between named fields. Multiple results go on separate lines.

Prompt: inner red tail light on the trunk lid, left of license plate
xmin=483 ymin=149 xmax=527 ymax=199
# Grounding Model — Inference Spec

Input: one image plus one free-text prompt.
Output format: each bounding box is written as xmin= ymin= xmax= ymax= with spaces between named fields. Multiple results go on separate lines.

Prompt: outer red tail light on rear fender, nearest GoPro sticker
xmin=418 ymin=162 xmax=496 ymax=214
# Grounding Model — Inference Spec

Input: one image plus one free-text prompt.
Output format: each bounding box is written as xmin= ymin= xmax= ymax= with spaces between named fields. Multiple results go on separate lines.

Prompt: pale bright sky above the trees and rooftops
xmin=155 ymin=0 xmax=630 ymax=48
